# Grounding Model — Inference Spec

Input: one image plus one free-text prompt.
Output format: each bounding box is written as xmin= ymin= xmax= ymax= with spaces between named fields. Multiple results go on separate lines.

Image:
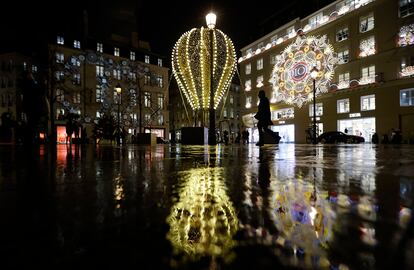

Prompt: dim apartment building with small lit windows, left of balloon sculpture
xmin=49 ymin=36 xmax=169 ymax=142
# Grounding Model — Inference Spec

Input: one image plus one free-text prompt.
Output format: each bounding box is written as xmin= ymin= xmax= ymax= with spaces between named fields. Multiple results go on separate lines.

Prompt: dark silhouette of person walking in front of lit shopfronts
xmin=254 ymin=90 xmax=280 ymax=146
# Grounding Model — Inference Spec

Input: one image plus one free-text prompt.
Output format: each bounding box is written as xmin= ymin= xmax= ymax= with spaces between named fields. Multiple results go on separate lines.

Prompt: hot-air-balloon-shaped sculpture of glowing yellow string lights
xmin=172 ymin=27 xmax=236 ymax=110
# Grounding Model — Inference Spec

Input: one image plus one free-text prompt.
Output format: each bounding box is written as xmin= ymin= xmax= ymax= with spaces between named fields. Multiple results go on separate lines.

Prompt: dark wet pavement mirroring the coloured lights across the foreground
xmin=0 ymin=144 xmax=414 ymax=269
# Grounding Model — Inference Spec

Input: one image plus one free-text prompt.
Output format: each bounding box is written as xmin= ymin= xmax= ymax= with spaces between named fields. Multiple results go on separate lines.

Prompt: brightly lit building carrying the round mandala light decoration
xmin=239 ymin=0 xmax=414 ymax=143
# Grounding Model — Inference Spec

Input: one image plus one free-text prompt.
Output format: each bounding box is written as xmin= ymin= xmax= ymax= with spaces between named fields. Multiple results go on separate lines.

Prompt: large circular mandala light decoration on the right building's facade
xmin=269 ymin=36 xmax=338 ymax=107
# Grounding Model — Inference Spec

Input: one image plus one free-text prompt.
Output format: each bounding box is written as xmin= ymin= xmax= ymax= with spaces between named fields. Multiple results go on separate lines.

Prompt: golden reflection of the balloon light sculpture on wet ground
xmin=167 ymin=168 xmax=237 ymax=257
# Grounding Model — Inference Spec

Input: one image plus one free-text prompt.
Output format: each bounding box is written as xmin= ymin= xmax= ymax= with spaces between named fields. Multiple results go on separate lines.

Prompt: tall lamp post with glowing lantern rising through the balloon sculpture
xmin=206 ymin=12 xmax=217 ymax=145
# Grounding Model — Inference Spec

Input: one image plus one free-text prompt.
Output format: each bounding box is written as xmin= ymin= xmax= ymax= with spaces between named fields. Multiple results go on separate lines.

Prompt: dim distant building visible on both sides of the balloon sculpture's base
xmin=170 ymin=83 xmax=242 ymax=142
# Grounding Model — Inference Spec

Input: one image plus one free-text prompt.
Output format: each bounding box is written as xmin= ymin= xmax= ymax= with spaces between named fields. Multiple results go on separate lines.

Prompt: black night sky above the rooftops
xmin=0 ymin=0 xmax=333 ymax=58
